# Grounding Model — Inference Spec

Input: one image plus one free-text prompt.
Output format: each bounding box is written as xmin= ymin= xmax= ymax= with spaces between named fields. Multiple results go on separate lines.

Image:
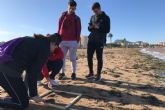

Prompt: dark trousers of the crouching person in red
xmin=47 ymin=60 xmax=63 ymax=79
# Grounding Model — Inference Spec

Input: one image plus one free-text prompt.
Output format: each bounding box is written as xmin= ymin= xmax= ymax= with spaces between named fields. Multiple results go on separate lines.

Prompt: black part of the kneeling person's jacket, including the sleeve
xmin=0 ymin=37 xmax=50 ymax=97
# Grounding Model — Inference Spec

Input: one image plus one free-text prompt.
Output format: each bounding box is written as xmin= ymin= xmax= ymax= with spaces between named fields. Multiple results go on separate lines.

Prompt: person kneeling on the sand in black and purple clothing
xmin=0 ymin=34 xmax=61 ymax=110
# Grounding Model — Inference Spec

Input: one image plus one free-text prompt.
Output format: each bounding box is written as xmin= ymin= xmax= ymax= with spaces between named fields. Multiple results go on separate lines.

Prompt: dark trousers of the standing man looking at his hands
xmin=87 ymin=41 xmax=104 ymax=75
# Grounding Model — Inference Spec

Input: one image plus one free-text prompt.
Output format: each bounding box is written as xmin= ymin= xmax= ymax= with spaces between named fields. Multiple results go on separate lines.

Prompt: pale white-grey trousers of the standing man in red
xmin=60 ymin=41 xmax=78 ymax=73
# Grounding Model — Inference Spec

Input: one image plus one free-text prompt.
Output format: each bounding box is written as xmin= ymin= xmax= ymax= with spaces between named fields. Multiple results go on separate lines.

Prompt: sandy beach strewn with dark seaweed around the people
xmin=0 ymin=49 xmax=165 ymax=110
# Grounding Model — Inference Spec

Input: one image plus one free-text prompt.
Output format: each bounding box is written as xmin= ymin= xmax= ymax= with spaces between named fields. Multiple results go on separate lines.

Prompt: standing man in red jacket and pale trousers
xmin=58 ymin=0 xmax=81 ymax=80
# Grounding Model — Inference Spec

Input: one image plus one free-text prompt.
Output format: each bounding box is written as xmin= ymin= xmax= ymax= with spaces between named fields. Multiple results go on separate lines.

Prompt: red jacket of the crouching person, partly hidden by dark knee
xmin=42 ymin=47 xmax=64 ymax=78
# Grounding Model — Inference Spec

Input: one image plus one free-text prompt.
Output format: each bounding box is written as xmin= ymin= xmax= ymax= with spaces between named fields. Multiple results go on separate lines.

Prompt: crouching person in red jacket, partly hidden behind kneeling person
xmin=42 ymin=47 xmax=64 ymax=88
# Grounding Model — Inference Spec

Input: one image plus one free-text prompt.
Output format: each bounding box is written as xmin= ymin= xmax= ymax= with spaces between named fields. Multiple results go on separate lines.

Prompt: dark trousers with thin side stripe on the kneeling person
xmin=0 ymin=73 xmax=29 ymax=110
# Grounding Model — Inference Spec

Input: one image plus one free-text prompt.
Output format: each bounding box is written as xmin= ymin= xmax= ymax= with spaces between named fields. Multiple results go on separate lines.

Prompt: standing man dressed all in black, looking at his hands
xmin=86 ymin=2 xmax=110 ymax=81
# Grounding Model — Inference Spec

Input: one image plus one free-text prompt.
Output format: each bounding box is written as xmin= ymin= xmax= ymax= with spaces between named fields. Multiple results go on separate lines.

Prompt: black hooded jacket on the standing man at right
xmin=88 ymin=12 xmax=110 ymax=43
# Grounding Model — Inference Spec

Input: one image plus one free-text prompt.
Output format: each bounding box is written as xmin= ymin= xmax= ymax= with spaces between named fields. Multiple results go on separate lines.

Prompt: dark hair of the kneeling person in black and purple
xmin=33 ymin=33 xmax=62 ymax=45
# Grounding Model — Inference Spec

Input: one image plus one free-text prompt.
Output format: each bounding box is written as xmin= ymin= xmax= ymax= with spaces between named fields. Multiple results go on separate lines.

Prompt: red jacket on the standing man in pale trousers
xmin=58 ymin=12 xmax=81 ymax=42
